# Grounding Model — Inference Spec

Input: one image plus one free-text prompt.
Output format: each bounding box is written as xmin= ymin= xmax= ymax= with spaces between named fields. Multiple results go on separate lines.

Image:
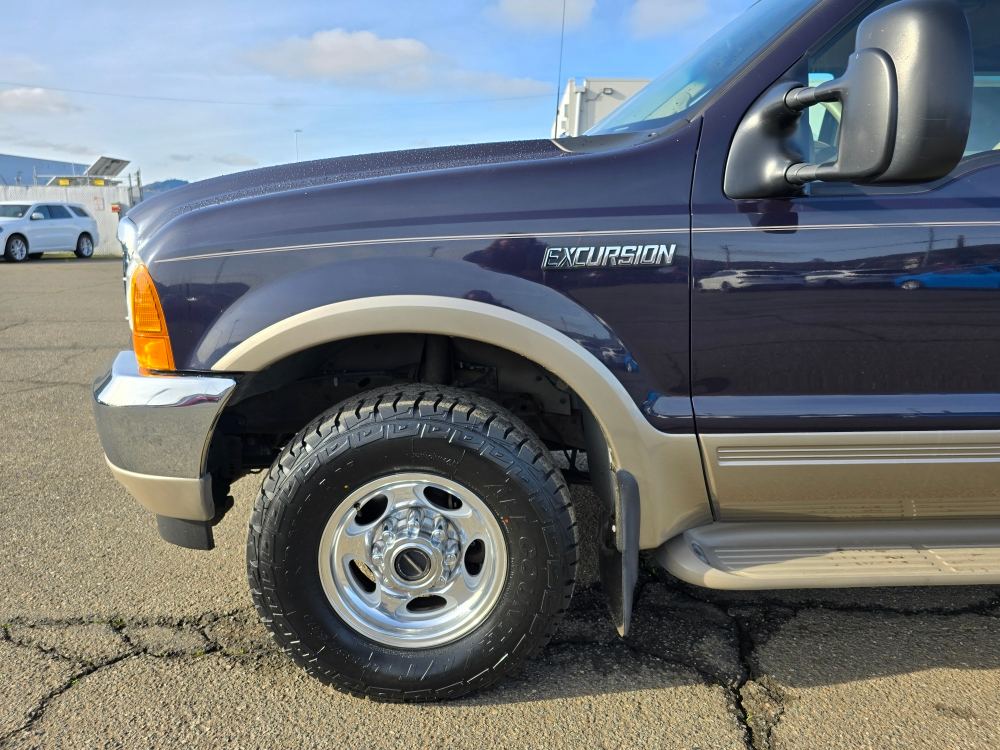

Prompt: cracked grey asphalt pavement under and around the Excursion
xmin=0 ymin=259 xmax=1000 ymax=750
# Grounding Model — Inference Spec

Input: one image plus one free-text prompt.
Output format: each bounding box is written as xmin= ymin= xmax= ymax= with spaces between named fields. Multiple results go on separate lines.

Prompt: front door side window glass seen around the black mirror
xmin=808 ymin=0 xmax=1000 ymax=162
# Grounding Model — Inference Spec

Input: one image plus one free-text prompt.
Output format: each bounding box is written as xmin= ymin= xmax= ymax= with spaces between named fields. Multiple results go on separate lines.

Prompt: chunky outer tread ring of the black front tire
xmin=247 ymin=384 xmax=579 ymax=702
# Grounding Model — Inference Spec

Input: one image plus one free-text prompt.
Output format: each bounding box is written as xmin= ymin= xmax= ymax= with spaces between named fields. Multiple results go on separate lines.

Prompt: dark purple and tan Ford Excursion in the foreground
xmin=94 ymin=0 xmax=1000 ymax=704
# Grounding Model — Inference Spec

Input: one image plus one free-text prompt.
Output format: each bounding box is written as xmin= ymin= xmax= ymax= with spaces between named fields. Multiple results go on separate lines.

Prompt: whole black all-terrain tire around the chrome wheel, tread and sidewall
xmin=247 ymin=385 xmax=578 ymax=701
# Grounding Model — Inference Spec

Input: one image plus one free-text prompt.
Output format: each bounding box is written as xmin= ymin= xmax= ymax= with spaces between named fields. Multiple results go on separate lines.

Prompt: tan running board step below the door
xmin=656 ymin=519 xmax=1000 ymax=590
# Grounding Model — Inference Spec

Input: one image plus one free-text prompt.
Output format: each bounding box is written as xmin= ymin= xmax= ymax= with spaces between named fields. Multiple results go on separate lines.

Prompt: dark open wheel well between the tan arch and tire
xmin=208 ymin=334 xmax=587 ymax=497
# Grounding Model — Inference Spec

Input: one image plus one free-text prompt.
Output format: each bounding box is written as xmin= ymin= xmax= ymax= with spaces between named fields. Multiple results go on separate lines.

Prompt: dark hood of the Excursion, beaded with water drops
xmin=128 ymin=139 xmax=580 ymax=235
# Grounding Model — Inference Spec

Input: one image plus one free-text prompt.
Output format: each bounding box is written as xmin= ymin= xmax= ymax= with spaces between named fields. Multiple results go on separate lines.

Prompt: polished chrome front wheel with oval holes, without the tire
xmin=319 ymin=473 xmax=507 ymax=648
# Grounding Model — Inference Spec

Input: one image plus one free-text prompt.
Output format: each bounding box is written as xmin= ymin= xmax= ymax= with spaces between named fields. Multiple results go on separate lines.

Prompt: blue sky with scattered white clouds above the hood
xmin=0 ymin=0 xmax=750 ymax=181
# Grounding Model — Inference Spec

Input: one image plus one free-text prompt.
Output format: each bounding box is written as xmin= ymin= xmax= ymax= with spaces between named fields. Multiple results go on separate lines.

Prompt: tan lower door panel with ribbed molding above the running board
xmin=700 ymin=430 xmax=1000 ymax=521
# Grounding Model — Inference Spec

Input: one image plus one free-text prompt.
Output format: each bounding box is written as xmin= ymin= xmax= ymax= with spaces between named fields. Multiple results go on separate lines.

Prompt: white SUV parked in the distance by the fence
xmin=0 ymin=201 xmax=100 ymax=263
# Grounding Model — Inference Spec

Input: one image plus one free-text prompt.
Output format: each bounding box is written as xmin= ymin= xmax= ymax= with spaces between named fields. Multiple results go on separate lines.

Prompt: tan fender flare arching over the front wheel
xmin=212 ymin=295 xmax=711 ymax=549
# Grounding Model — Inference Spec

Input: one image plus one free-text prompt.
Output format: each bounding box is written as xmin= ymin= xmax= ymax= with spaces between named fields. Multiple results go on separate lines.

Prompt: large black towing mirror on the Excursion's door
xmin=725 ymin=0 xmax=973 ymax=198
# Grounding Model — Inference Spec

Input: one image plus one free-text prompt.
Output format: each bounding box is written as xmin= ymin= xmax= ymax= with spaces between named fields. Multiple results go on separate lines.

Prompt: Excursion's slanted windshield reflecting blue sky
xmin=586 ymin=0 xmax=816 ymax=135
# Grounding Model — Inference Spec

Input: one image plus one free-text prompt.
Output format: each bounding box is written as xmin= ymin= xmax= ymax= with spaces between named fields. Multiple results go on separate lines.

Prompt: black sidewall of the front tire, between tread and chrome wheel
xmin=261 ymin=416 xmax=568 ymax=693
